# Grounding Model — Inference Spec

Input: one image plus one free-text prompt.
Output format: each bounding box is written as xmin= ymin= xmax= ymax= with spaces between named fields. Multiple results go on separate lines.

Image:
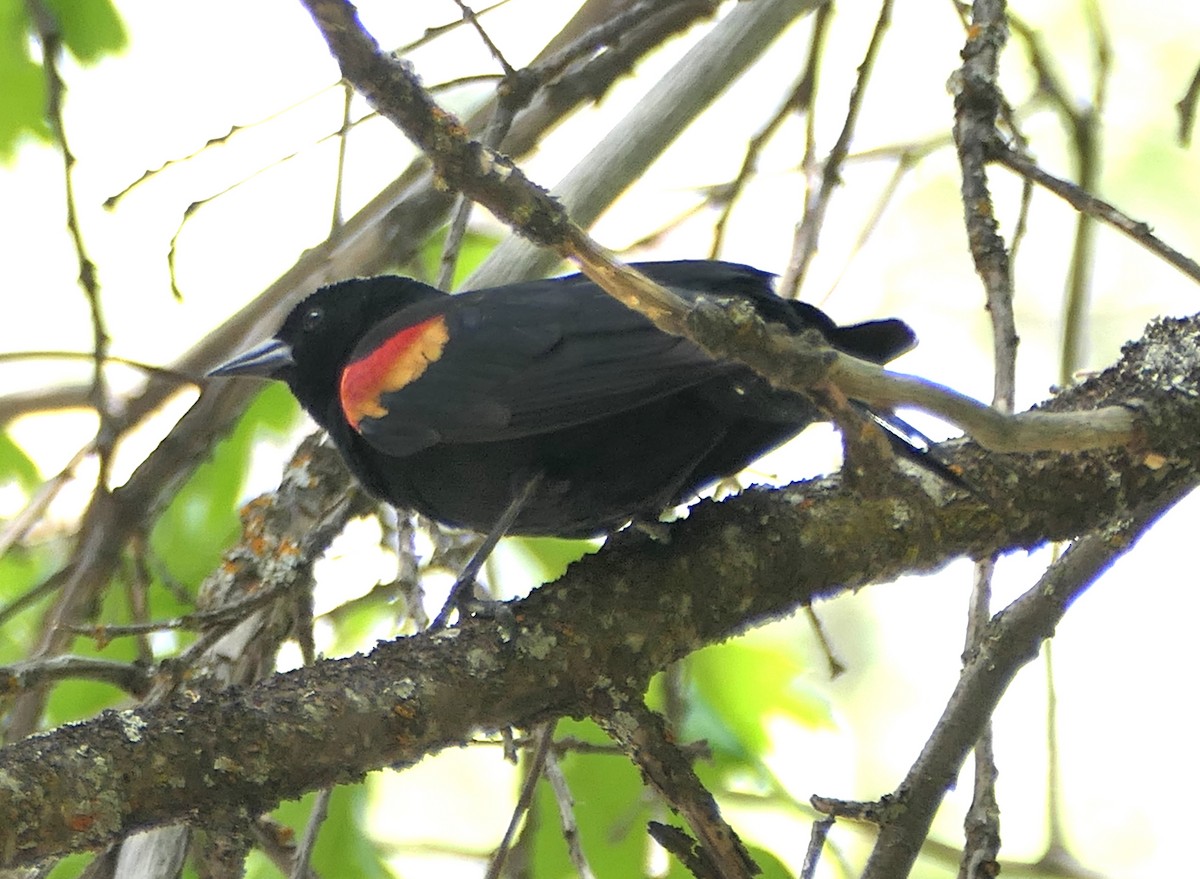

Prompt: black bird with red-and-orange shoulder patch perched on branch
xmin=211 ymin=261 xmax=916 ymax=537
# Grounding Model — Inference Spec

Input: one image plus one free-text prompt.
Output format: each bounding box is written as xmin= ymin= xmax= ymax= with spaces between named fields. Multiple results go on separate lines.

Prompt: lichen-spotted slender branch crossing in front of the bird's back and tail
xmin=295 ymin=0 xmax=1136 ymax=463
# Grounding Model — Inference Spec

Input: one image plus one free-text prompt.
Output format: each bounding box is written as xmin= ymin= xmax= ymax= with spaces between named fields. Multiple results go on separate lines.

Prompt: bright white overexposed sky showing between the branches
xmin=0 ymin=0 xmax=1200 ymax=877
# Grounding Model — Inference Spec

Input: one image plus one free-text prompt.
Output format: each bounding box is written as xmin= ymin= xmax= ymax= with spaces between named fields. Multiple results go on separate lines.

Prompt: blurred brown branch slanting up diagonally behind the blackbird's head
xmin=0 ymin=0 xmax=709 ymax=737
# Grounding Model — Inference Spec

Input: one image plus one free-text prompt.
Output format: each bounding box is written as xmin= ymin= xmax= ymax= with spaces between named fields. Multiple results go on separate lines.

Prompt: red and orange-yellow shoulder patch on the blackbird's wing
xmin=340 ymin=315 xmax=450 ymax=430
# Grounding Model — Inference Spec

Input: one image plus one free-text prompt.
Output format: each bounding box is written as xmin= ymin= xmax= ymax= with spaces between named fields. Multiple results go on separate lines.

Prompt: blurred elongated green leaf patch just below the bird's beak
xmin=150 ymin=383 xmax=300 ymax=588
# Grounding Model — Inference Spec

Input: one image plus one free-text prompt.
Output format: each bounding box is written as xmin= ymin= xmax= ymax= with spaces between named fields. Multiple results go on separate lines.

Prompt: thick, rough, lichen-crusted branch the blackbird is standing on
xmin=0 ymin=309 xmax=1200 ymax=866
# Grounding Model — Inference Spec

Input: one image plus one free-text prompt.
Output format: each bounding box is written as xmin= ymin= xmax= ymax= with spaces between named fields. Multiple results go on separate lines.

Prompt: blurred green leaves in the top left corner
xmin=0 ymin=0 xmax=127 ymax=163
